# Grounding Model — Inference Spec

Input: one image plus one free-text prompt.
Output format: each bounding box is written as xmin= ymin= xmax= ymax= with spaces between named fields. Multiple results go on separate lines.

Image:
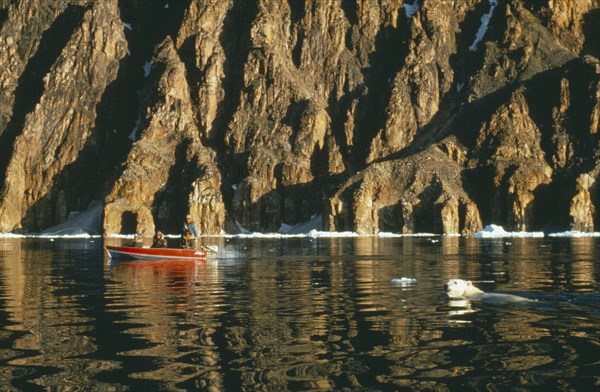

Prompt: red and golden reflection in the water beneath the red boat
xmin=105 ymin=261 xmax=224 ymax=389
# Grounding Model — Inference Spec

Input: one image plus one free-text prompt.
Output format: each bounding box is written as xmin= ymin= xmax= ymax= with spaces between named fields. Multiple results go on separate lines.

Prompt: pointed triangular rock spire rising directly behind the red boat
xmin=104 ymin=38 xmax=224 ymax=234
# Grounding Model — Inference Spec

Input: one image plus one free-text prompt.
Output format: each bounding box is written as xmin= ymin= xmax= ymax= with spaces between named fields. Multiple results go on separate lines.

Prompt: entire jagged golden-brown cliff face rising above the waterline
xmin=0 ymin=0 xmax=600 ymax=234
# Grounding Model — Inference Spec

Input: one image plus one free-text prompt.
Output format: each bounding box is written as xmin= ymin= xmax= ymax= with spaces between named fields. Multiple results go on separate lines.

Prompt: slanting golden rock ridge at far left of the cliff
xmin=0 ymin=1 xmax=127 ymax=232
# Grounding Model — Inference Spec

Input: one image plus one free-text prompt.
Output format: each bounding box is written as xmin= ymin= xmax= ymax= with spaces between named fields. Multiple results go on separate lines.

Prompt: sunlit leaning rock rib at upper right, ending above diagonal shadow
xmin=367 ymin=2 xmax=473 ymax=162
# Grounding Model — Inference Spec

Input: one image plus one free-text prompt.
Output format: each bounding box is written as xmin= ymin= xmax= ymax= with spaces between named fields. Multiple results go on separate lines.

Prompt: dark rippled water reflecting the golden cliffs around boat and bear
xmin=0 ymin=234 xmax=600 ymax=391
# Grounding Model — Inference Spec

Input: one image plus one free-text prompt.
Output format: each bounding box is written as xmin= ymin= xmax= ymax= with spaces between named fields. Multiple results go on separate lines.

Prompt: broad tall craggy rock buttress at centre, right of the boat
xmin=225 ymin=1 xmax=353 ymax=231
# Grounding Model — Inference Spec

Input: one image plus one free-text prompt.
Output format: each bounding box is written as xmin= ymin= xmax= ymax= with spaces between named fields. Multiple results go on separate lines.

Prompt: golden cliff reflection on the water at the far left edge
xmin=0 ymin=239 xmax=115 ymax=389
